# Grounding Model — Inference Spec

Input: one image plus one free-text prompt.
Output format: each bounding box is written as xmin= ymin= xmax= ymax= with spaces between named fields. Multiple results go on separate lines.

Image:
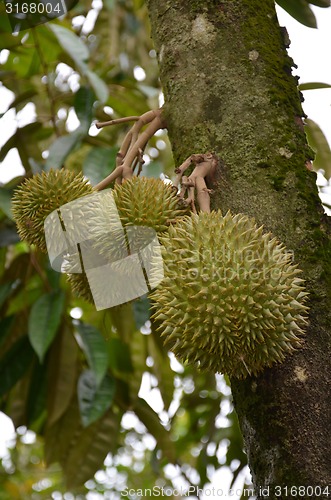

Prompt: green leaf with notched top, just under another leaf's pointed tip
xmin=77 ymin=370 xmax=115 ymax=427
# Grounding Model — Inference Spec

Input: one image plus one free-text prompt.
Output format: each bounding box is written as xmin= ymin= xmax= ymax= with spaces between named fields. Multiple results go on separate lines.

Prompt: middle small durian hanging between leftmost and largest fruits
xmin=91 ymin=176 xmax=188 ymax=260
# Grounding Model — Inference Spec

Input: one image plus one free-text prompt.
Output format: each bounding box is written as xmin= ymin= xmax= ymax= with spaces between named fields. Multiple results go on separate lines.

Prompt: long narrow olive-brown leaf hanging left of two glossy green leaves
xmin=47 ymin=325 xmax=78 ymax=425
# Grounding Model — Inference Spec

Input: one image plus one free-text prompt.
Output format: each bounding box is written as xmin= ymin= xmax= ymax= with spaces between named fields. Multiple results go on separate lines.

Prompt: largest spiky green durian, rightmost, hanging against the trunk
xmin=151 ymin=212 xmax=308 ymax=378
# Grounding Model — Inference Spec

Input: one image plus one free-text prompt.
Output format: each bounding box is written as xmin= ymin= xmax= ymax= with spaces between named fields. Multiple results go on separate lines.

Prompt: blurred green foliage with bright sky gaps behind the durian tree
xmin=0 ymin=0 xmax=331 ymax=500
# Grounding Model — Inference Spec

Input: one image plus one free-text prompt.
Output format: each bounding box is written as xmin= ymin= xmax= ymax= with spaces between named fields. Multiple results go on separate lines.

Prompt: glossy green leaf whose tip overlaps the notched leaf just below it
xmin=77 ymin=324 xmax=108 ymax=386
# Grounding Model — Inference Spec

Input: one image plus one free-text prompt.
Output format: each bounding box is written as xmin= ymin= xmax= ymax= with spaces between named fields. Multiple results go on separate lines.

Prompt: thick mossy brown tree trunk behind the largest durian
xmin=148 ymin=0 xmax=331 ymax=499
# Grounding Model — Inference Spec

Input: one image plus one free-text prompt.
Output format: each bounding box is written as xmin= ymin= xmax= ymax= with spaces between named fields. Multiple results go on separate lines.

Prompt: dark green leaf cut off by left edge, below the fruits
xmin=0 ymin=336 xmax=33 ymax=396
